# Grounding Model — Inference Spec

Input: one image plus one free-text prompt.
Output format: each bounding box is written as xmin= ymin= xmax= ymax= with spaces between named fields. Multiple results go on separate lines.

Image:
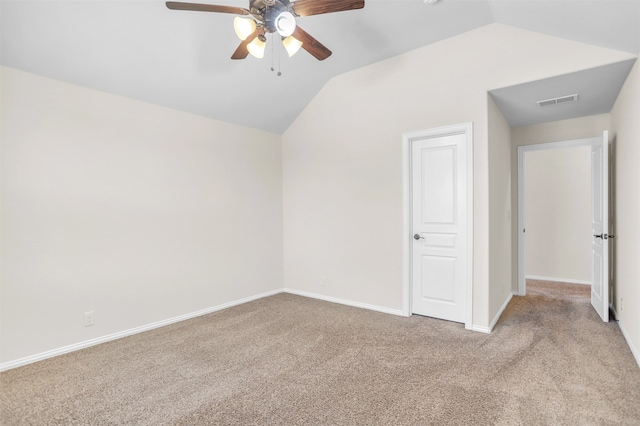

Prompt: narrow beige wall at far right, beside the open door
xmin=611 ymin=62 xmax=640 ymax=364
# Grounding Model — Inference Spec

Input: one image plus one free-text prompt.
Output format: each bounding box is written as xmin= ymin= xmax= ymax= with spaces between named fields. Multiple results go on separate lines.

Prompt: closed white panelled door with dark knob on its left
xmin=411 ymin=133 xmax=471 ymax=323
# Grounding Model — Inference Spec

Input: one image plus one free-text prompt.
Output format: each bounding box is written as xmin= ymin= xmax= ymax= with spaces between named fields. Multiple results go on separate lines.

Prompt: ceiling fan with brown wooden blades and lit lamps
xmin=166 ymin=0 xmax=364 ymax=61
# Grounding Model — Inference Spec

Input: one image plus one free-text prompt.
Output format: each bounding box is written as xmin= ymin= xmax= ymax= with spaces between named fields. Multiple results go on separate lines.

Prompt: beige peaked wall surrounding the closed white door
xmin=283 ymin=24 xmax=632 ymax=327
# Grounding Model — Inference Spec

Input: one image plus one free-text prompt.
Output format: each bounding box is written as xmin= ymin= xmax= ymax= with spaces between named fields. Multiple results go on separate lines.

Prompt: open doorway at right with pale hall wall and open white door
xmin=518 ymin=131 xmax=610 ymax=321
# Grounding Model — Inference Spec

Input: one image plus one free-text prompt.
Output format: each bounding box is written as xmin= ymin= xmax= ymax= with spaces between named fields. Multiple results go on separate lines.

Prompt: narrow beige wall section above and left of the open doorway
xmin=511 ymin=114 xmax=611 ymax=292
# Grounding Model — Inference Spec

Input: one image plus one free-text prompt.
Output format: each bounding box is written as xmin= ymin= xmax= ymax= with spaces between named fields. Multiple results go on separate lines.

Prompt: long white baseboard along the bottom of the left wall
xmin=0 ymin=289 xmax=282 ymax=371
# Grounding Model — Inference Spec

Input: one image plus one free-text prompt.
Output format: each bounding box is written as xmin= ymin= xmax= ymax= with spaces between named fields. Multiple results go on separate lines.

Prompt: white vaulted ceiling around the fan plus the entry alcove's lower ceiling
xmin=0 ymin=0 xmax=640 ymax=134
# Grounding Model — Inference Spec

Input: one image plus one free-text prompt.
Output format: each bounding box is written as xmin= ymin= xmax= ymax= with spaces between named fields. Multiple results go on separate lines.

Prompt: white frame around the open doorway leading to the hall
xmin=517 ymin=135 xmax=602 ymax=296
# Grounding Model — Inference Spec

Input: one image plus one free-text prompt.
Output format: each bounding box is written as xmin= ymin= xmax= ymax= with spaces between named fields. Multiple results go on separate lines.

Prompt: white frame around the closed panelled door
xmin=402 ymin=122 xmax=473 ymax=330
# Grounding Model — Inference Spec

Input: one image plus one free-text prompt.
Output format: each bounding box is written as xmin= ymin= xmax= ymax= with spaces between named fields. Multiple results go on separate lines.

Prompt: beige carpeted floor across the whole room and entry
xmin=0 ymin=282 xmax=640 ymax=425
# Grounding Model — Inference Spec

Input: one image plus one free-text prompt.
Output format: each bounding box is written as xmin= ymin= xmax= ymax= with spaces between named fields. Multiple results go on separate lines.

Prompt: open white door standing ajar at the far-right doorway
xmin=591 ymin=131 xmax=609 ymax=322
